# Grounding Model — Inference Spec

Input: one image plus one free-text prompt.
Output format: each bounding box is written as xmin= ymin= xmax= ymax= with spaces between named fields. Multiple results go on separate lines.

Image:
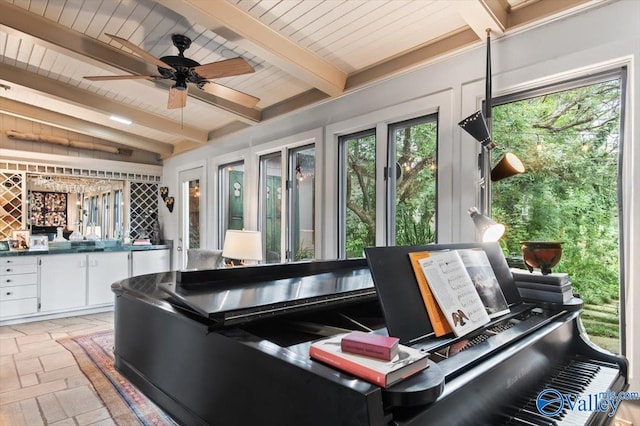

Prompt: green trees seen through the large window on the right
xmin=492 ymin=80 xmax=620 ymax=303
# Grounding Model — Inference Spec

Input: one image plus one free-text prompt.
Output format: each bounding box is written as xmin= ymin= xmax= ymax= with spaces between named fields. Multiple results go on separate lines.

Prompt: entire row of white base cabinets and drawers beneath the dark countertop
xmin=0 ymin=249 xmax=171 ymax=321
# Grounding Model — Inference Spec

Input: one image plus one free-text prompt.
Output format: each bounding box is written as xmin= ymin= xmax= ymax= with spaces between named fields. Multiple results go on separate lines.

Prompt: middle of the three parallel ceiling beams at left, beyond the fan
xmin=0 ymin=64 xmax=207 ymax=144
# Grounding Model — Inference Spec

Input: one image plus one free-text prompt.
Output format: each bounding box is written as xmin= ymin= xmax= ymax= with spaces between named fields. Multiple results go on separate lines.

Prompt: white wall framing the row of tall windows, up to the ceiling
xmin=162 ymin=0 xmax=640 ymax=390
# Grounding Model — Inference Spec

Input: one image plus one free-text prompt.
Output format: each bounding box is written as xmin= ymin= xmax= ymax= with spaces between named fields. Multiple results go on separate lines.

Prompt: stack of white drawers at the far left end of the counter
xmin=0 ymin=256 xmax=38 ymax=318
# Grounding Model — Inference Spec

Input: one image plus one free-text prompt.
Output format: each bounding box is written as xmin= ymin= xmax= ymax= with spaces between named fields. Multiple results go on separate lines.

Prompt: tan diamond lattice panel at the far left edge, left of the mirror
xmin=0 ymin=170 xmax=25 ymax=240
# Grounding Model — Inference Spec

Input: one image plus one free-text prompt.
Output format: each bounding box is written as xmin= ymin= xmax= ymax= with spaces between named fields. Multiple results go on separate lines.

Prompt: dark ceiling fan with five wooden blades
xmin=84 ymin=34 xmax=260 ymax=109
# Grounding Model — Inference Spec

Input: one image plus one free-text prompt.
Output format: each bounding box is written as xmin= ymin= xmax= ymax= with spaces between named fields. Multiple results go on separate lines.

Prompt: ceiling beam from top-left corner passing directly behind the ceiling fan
xmin=0 ymin=1 xmax=260 ymax=127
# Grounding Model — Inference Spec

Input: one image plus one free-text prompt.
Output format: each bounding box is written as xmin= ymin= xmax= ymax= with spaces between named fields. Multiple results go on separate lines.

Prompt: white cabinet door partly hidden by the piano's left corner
xmin=87 ymin=252 xmax=129 ymax=306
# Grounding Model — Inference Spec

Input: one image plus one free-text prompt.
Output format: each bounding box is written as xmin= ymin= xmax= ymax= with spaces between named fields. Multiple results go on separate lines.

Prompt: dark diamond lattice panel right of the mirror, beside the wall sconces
xmin=129 ymin=182 xmax=158 ymax=238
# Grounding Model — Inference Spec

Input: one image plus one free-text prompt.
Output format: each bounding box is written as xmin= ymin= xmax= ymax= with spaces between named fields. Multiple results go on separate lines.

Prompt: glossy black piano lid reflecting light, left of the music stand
xmin=159 ymin=259 xmax=376 ymax=324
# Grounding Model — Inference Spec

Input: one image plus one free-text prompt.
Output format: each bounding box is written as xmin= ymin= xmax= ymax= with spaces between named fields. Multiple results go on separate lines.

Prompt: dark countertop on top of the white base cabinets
xmin=0 ymin=240 xmax=173 ymax=257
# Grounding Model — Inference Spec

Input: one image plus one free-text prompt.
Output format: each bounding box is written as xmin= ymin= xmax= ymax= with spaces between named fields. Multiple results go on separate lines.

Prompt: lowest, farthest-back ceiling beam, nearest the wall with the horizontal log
xmin=0 ymin=97 xmax=173 ymax=155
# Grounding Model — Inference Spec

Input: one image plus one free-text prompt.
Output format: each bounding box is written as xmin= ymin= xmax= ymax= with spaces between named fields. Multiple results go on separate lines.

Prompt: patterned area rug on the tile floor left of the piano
xmin=58 ymin=331 xmax=176 ymax=426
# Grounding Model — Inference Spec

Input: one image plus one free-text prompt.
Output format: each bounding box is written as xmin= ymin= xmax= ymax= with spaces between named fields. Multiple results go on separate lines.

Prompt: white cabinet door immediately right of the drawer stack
xmin=40 ymin=254 xmax=87 ymax=312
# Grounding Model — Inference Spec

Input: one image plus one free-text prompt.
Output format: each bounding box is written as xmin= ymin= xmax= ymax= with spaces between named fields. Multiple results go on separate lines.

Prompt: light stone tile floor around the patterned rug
xmin=0 ymin=312 xmax=640 ymax=426
